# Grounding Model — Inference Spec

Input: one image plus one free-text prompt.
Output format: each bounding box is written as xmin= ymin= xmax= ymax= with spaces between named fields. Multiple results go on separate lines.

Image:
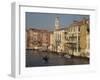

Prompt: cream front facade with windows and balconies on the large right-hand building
xmin=65 ymin=21 xmax=80 ymax=56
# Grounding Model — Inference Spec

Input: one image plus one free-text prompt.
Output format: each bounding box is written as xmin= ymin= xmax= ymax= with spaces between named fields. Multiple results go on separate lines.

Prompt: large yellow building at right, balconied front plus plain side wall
xmin=65 ymin=18 xmax=90 ymax=57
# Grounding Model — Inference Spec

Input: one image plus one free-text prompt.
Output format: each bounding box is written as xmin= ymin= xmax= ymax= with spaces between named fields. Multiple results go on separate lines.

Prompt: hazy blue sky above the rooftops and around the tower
xmin=25 ymin=12 xmax=89 ymax=31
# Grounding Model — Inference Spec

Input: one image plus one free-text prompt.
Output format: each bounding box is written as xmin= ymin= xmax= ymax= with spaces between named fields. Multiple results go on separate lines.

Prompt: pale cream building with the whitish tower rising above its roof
xmin=53 ymin=16 xmax=64 ymax=52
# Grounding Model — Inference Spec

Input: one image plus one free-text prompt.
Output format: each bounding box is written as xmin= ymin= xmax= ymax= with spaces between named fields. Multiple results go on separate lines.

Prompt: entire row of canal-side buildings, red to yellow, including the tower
xmin=27 ymin=17 xmax=90 ymax=57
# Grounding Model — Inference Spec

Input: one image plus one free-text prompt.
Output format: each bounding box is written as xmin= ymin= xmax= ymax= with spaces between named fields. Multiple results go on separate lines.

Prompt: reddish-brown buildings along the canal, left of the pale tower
xmin=27 ymin=28 xmax=50 ymax=50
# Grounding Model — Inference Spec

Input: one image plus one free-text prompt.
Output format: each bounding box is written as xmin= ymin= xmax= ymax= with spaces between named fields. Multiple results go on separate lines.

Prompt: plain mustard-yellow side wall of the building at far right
xmin=80 ymin=18 xmax=90 ymax=57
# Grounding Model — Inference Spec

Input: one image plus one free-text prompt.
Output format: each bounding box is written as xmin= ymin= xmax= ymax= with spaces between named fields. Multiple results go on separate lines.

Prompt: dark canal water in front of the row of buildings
xmin=26 ymin=50 xmax=89 ymax=67
